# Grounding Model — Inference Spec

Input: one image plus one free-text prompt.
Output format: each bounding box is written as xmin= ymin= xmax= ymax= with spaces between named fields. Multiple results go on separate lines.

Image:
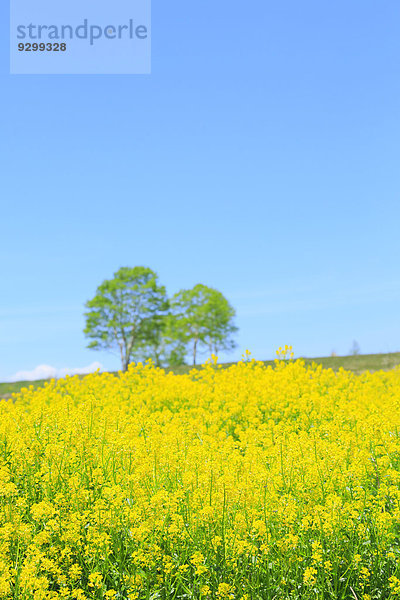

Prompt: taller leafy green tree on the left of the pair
xmin=84 ymin=267 xmax=168 ymax=370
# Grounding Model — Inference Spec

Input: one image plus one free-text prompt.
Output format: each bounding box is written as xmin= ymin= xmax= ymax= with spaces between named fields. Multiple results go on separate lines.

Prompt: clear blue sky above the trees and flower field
xmin=0 ymin=0 xmax=400 ymax=380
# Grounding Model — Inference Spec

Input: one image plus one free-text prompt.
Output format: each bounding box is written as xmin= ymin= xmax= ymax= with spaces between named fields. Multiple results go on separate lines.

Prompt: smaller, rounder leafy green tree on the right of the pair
xmin=170 ymin=283 xmax=237 ymax=365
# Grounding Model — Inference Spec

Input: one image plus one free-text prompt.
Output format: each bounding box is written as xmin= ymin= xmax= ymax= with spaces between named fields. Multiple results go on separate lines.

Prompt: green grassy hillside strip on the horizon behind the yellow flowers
xmin=0 ymin=352 xmax=400 ymax=398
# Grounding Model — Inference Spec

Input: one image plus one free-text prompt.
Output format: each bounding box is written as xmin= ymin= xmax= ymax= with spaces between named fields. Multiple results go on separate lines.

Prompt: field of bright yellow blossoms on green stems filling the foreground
xmin=0 ymin=350 xmax=400 ymax=600
